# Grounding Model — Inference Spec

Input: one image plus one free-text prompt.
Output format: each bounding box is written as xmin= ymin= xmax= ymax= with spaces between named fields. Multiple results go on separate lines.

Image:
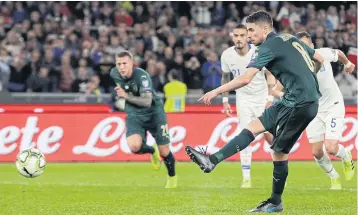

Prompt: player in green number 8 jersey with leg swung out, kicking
xmin=185 ymin=11 xmax=323 ymax=212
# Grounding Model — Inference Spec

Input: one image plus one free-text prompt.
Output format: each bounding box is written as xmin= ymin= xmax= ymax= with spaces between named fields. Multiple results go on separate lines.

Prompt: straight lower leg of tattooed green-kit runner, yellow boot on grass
xmin=159 ymin=144 xmax=178 ymax=188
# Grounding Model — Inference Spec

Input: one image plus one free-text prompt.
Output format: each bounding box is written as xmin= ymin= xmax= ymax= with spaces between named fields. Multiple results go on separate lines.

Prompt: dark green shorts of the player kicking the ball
xmin=259 ymin=102 xmax=318 ymax=154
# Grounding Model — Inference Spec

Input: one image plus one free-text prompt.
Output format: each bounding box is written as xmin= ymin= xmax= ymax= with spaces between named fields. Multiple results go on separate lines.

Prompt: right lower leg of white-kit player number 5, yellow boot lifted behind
xmin=324 ymin=139 xmax=354 ymax=180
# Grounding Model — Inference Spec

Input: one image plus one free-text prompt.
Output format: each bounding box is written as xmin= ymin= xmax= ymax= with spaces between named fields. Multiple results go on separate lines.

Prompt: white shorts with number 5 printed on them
xmin=306 ymin=105 xmax=346 ymax=143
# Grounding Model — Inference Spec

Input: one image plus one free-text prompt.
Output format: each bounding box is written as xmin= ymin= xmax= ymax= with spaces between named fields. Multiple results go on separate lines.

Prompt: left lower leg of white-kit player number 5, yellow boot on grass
xmin=311 ymin=141 xmax=342 ymax=190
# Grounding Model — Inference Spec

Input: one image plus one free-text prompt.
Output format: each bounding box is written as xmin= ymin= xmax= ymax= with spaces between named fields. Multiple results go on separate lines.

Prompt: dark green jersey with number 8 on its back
xmin=247 ymin=32 xmax=321 ymax=107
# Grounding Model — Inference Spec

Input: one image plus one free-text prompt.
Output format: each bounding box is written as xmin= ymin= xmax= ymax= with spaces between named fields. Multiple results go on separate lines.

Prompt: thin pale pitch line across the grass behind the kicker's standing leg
xmin=0 ymin=181 xmax=358 ymax=192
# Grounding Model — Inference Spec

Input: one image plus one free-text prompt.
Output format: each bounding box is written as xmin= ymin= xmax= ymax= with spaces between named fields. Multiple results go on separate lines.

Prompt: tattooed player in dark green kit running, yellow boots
xmin=110 ymin=51 xmax=177 ymax=188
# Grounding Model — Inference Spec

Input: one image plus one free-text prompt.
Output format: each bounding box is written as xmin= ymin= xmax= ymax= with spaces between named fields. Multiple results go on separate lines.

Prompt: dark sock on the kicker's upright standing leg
xmin=270 ymin=160 xmax=288 ymax=205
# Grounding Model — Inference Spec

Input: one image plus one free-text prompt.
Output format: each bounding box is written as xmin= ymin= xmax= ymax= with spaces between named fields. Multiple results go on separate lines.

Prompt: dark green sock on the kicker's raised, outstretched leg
xmin=210 ymin=129 xmax=255 ymax=165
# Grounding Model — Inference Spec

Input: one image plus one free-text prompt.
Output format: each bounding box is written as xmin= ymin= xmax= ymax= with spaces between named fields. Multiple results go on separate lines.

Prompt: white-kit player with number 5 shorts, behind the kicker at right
xmin=273 ymin=32 xmax=355 ymax=190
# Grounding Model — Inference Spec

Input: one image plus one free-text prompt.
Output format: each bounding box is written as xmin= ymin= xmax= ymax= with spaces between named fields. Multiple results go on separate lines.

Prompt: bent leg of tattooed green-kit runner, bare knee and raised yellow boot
xmin=127 ymin=134 xmax=160 ymax=169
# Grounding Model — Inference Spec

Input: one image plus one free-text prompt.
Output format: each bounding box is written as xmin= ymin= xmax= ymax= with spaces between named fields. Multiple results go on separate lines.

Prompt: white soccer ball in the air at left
xmin=16 ymin=148 xmax=46 ymax=178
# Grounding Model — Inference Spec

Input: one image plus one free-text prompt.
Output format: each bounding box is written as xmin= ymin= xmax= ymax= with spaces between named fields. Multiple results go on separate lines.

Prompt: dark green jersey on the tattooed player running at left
xmin=110 ymin=67 xmax=163 ymax=115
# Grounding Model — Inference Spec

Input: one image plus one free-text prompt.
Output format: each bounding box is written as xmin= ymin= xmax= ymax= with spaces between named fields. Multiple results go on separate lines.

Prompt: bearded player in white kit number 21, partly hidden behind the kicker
xmin=221 ymin=25 xmax=276 ymax=188
